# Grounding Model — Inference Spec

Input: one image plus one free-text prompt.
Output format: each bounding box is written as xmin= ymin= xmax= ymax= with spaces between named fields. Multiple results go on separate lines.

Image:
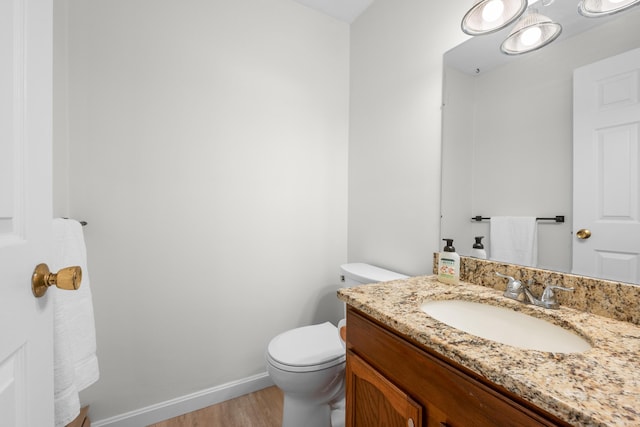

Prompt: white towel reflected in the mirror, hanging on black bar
xmin=489 ymin=216 xmax=538 ymax=267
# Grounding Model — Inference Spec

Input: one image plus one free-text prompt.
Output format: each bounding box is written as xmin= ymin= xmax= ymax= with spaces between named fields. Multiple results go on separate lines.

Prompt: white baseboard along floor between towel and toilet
xmin=91 ymin=372 xmax=273 ymax=427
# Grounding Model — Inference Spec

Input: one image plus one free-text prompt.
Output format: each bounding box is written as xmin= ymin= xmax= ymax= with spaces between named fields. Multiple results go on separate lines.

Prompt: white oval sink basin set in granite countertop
xmin=420 ymin=300 xmax=591 ymax=353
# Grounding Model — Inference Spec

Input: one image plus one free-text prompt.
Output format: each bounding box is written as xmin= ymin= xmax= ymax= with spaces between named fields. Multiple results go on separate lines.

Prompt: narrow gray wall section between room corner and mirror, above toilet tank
xmin=349 ymin=0 xmax=469 ymax=275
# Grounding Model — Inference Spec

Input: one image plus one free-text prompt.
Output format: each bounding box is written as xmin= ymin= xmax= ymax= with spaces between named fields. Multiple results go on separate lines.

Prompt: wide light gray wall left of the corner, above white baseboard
xmin=54 ymin=0 xmax=349 ymax=421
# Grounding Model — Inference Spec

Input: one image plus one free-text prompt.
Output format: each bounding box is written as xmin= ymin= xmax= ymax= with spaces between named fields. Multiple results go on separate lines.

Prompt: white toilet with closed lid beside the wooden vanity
xmin=266 ymin=263 xmax=407 ymax=427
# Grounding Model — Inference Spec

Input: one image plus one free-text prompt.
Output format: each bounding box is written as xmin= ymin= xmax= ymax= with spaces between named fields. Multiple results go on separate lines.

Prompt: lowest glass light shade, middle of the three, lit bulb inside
xmin=500 ymin=10 xmax=562 ymax=55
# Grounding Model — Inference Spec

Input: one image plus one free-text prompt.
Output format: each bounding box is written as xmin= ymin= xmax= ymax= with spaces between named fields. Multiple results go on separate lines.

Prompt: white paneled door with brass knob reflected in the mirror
xmin=573 ymin=49 xmax=640 ymax=283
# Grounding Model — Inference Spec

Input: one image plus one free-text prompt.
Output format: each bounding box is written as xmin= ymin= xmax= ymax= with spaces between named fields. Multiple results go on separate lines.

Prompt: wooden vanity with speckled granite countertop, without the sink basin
xmin=338 ymin=266 xmax=640 ymax=427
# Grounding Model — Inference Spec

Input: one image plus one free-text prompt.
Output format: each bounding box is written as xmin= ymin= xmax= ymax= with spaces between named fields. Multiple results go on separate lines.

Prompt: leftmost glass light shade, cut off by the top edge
xmin=462 ymin=0 xmax=528 ymax=36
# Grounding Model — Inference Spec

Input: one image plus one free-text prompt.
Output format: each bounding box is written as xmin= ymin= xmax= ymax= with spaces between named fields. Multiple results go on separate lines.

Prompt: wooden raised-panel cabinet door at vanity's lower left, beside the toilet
xmin=346 ymin=352 xmax=422 ymax=427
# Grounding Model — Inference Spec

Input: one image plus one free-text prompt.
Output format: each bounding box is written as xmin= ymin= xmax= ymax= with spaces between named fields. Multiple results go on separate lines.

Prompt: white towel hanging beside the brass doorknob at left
xmin=49 ymin=218 xmax=99 ymax=427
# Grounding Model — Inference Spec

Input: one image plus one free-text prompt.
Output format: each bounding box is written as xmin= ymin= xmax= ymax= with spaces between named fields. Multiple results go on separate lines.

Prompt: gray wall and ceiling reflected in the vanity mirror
xmin=441 ymin=0 xmax=640 ymax=280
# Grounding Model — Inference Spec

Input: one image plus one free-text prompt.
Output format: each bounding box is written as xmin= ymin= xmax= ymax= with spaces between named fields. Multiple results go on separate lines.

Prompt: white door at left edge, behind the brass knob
xmin=0 ymin=0 xmax=53 ymax=427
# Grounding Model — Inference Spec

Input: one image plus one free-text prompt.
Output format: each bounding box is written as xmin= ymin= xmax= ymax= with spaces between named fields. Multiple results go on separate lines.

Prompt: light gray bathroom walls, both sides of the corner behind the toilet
xmin=54 ymin=0 xmax=490 ymax=419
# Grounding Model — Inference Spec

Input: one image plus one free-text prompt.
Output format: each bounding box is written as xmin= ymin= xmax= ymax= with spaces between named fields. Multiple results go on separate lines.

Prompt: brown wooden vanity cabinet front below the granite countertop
xmin=346 ymin=307 xmax=569 ymax=427
